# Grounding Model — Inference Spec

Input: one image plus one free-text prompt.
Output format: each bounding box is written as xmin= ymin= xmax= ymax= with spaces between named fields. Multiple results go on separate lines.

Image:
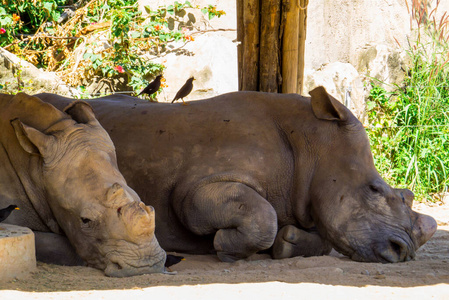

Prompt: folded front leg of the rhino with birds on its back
xmin=181 ymin=182 xmax=277 ymax=262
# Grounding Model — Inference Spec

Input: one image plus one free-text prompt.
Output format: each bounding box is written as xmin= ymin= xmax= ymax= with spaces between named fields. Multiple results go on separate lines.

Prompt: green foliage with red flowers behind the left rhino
xmin=0 ymin=0 xmax=224 ymax=96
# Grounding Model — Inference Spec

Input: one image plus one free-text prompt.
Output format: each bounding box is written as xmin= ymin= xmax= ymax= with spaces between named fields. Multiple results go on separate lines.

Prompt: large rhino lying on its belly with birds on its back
xmin=39 ymin=87 xmax=436 ymax=262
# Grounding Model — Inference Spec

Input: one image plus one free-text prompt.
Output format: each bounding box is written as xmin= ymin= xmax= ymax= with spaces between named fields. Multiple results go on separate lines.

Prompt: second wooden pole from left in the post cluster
xmin=259 ymin=0 xmax=281 ymax=93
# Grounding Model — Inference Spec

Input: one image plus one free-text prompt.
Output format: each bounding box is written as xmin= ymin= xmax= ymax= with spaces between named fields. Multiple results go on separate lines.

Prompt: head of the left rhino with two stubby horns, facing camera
xmin=11 ymin=96 xmax=166 ymax=277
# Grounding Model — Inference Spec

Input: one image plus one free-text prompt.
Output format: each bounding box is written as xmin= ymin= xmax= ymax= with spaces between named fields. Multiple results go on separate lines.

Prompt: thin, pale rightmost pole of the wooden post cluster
xmin=296 ymin=0 xmax=309 ymax=95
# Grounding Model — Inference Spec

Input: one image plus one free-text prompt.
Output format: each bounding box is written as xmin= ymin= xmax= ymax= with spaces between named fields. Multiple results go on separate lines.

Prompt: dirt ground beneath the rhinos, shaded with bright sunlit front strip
xmin=0 ymin=203 xmax=449 ymax=300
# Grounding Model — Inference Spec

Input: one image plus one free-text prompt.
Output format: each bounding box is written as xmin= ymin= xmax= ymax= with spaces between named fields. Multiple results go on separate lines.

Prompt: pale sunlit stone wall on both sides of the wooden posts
xmin=0 ymin=0 xmax=449 ymax=110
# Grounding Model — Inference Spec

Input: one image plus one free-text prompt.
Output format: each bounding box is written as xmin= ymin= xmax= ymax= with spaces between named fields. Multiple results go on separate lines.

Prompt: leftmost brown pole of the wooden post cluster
xmin=237 ymin=0 xmax=260 ymax=91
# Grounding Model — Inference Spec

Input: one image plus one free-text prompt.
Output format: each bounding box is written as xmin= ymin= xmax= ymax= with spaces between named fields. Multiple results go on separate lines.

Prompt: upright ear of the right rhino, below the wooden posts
xmin=309 ymin=86 xmax=348 ymax=121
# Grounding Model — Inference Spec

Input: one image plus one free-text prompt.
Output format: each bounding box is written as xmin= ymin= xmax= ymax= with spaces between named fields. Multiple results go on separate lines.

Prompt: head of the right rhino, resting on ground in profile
xmin=299 ymin=87 xmax=437 ymax=262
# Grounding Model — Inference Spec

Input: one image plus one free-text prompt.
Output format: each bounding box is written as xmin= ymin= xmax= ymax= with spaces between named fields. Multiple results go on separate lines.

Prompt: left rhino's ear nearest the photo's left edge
xmin=11 ymin=119 xmax=54 ymax=155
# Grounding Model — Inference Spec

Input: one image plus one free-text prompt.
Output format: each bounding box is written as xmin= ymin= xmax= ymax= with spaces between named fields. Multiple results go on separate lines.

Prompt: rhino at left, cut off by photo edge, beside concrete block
xmin=0 ymin=94 xmax=165 ymax=277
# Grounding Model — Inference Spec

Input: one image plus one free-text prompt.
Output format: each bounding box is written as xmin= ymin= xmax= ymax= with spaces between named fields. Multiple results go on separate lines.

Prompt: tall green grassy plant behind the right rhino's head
xmin=367 ymin=0 xmax=449 ymax=199
